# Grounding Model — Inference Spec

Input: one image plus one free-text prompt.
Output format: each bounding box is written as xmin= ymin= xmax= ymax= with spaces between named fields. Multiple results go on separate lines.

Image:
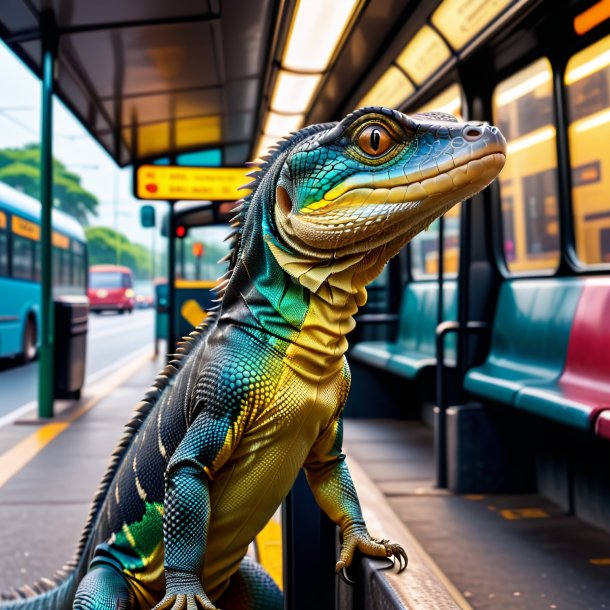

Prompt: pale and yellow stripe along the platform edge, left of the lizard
xmin=0 ymin=348 xmax=150 ymax=487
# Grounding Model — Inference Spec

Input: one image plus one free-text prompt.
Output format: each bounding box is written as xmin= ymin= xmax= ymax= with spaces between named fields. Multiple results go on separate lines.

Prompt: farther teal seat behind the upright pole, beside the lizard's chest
xmin=350 ymin=282 xmax=457 ymax=379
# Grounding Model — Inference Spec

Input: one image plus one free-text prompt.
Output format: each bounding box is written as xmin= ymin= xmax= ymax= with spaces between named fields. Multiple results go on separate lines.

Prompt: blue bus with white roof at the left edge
xmin=0 ymin=182 xmax=87 ymax=362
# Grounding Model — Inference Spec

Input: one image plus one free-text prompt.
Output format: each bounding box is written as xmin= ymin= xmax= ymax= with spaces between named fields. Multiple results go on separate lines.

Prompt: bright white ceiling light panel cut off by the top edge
xmin=282 ymin=0 xmax=359 ymax=72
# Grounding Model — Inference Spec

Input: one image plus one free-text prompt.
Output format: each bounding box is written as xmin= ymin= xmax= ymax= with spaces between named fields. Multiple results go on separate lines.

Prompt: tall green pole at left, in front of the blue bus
xmin=38 ymin=11 xmax=57 ymax=417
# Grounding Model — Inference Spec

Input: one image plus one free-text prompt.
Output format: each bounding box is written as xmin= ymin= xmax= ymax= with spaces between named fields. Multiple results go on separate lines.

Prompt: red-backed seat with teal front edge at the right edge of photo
xmin=515 ymin=277 xmax=610 ymax=430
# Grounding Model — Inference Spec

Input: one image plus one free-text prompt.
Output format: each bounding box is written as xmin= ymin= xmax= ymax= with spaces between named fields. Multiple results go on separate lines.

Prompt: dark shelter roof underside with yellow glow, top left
xmin=0 ymin=0 xmax=274 ymax=165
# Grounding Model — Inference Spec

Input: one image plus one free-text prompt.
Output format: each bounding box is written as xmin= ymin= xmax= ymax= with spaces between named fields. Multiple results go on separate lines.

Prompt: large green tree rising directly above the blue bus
xmin=0 ymin=144 xmax=98 ymax=225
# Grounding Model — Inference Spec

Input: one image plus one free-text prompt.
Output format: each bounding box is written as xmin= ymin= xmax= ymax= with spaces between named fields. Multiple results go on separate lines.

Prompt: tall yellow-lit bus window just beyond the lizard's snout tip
xmin=493 ymin=58 xmax=559 ymax=273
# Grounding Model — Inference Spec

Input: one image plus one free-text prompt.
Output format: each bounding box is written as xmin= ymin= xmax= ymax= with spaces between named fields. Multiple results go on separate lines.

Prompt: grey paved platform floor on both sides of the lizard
xmin=0 ymin=353 xmax=610 ymax=610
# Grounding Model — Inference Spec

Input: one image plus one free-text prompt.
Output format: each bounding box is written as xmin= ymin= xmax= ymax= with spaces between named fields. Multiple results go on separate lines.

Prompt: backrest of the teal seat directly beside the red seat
xmin=488 ymin=278 xmax=583 ymax=378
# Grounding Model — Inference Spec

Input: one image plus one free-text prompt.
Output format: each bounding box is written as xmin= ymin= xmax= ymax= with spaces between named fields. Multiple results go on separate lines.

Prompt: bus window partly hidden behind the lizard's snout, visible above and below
xmin=411 ymin=83 xmax=463 ymax=279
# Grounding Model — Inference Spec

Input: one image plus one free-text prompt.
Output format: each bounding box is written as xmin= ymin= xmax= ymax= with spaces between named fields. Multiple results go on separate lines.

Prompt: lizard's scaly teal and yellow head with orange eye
xmin=274 ymin=107 xmax=506 ymax=258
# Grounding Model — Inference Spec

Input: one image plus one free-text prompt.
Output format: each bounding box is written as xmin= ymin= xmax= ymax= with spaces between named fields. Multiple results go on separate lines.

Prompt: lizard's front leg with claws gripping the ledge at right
xmin=305 ymin=418 xmax=408 ymax=580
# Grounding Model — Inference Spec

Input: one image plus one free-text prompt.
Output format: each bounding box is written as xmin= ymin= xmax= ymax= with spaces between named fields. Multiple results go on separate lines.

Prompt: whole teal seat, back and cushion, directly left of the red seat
xmin=464 ymin=278 xmax=583 ymax=405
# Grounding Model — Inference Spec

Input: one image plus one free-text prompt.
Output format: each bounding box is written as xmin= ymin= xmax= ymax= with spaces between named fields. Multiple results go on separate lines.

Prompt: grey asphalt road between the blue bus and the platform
xmin=0 ymin=309 xmax=154 ymax=425
